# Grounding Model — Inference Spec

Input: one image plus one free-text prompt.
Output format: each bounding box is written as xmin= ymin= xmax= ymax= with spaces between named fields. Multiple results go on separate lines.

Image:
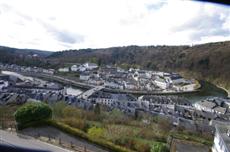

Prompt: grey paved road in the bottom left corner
xmin=0 ymin=130 xmax=70 ymax=152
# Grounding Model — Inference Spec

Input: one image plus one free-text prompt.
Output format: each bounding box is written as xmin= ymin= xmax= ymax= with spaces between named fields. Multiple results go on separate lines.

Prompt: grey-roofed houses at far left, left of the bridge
xmin=0 ymin=71 xmax=66 ymax=104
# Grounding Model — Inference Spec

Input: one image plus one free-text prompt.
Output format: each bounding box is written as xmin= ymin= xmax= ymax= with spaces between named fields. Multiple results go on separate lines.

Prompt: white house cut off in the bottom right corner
xmin=212 ymin=124 xmax=230 ymax=152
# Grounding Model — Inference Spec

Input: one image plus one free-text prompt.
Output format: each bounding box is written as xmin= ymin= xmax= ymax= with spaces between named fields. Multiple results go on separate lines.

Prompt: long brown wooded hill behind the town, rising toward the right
xmin=47 ymin=41 xmax=230 ymax=90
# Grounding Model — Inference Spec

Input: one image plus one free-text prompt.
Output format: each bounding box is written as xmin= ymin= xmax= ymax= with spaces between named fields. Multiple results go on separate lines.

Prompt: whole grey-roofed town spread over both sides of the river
xmin=0 ymin=63 xmax=230 ymax=152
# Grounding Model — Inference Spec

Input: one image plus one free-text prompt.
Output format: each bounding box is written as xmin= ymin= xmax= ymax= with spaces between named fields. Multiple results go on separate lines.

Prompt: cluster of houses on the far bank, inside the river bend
xmin=58 ymin=63 xmax=199 ymax=92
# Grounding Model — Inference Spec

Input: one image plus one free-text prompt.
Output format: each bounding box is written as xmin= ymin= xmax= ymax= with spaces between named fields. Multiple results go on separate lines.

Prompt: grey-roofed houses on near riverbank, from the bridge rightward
xmin=74 ymin=88 xmax=230 ymax=121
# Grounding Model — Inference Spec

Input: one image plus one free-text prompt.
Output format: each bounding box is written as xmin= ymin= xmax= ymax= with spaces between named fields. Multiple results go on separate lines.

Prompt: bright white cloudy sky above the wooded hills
xmin=0 ymin=0 xmax=230 ymax=51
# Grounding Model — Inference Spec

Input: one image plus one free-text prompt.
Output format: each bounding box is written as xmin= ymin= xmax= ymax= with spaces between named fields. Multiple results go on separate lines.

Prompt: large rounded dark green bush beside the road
xmin=14 ymin=102 xmax=52 ymax=125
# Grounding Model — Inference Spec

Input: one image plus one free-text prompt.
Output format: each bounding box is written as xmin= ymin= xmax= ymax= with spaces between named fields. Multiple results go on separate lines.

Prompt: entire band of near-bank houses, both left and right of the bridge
xmin=0 ymin=68 xmax=230 ymax=124
